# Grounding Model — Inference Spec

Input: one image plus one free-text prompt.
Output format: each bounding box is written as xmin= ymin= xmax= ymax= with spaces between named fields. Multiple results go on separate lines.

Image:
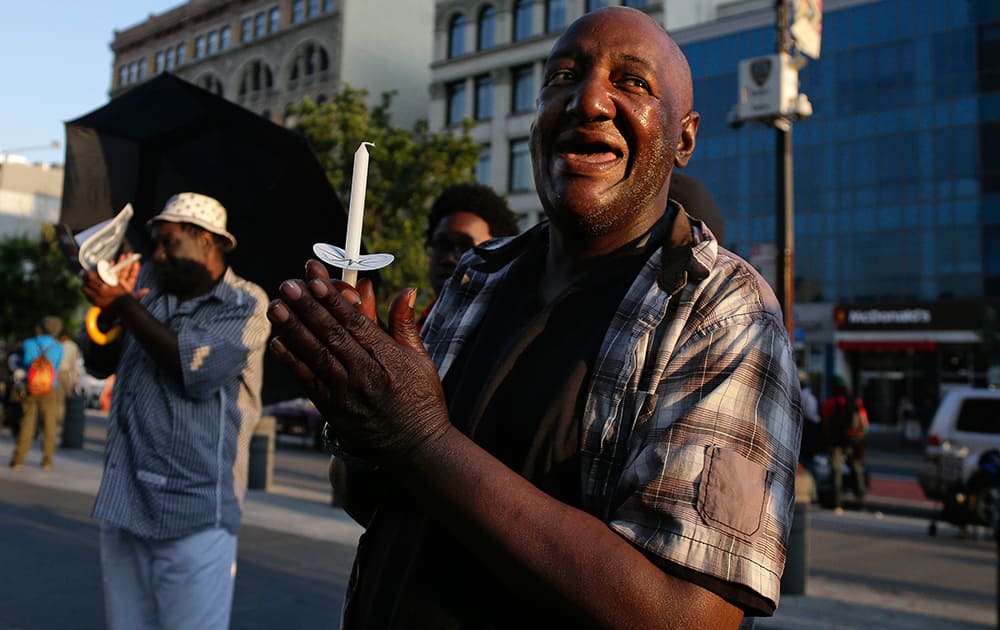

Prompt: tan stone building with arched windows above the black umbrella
xmin=110 ymin=0 xmax=434 ymax=126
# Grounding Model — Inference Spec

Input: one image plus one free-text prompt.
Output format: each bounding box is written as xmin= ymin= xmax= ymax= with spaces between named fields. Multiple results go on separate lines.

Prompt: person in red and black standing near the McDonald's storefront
xmin=822 ymin=374 xmax=868 ymax=511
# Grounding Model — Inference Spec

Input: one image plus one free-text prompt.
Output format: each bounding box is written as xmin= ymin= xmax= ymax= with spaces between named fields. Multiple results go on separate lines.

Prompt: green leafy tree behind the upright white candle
xmin=292 ymin=86 xmax=481 ymax=309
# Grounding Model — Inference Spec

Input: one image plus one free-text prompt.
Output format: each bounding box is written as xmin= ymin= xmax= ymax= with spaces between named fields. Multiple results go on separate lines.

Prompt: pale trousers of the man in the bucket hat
xmin=101 ymin=523 xmax=236 ymax=630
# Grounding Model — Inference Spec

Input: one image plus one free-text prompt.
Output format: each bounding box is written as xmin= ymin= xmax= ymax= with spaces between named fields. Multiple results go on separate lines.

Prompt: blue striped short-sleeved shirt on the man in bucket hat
xmin=93 ymin=265 xmax=271 ymax=540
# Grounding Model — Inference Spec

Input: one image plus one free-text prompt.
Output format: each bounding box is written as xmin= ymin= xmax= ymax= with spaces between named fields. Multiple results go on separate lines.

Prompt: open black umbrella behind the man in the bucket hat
xmin=60 ymin=74 xmax=347 ymax=401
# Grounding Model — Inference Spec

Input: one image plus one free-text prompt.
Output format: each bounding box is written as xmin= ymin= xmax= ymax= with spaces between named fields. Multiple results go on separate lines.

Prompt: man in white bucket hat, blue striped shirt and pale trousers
xmin=83 ymin=192 xmax=270 ymax=628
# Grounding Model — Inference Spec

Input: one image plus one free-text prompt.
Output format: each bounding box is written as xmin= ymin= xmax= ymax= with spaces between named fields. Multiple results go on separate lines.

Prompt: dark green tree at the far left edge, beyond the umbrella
xmin=0 ymin=226 xmax=85 ymax=343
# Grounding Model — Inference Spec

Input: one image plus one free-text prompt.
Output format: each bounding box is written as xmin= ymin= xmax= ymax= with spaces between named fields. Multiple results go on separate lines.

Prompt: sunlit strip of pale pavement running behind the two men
xmin=0 ymin=433 xmax=992 ymax=630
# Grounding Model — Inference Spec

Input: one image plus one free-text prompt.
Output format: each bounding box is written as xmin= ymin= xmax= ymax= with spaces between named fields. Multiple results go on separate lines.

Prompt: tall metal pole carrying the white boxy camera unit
xmin=774 ymin=0 xmax=795 ymax=339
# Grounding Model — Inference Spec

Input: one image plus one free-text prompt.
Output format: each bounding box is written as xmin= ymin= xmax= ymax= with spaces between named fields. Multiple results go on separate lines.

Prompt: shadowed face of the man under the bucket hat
xmin=153 ymin=221 xmax=212 ymax=297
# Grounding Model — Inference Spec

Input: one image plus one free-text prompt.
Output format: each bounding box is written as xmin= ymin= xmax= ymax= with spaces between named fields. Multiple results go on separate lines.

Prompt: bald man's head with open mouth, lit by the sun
xmin=531 ymin=8 xmax=697 ymax=244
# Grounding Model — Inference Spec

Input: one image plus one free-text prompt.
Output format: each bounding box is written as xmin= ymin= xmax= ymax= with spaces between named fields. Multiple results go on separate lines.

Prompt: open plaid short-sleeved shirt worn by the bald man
xmin=423 ymin=208 xmax=802 ymax=605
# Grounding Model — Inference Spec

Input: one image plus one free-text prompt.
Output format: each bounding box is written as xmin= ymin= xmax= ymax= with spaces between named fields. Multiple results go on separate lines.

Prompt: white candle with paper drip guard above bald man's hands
xmin=313 ymin=142 xmax=396 ymax=286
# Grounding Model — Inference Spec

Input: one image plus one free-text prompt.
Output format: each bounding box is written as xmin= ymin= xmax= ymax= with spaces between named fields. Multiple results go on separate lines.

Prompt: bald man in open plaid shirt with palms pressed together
xmin=268 ymin=6 xmax=802 ymax=629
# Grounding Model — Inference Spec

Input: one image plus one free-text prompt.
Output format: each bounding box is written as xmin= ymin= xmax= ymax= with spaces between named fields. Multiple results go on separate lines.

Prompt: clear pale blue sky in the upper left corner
xmin=0 ymin=0 xmax=184 ymax=162
